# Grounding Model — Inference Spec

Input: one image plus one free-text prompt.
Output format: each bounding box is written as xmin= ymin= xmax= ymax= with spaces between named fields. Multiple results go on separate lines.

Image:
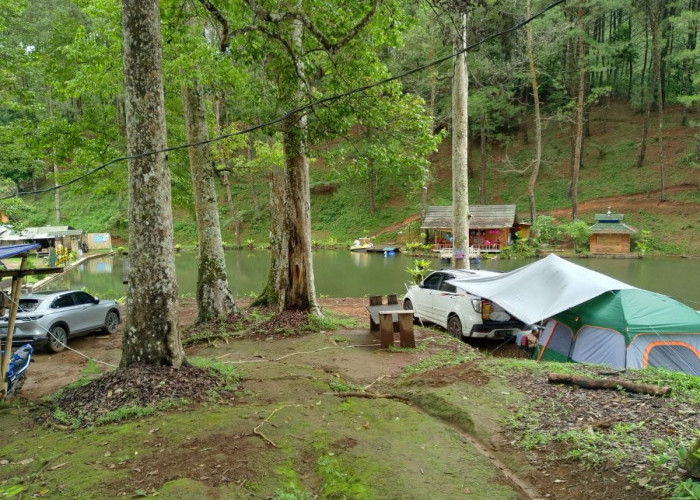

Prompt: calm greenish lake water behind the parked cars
xmin=46 ymin=250 xmax=700 ymax=309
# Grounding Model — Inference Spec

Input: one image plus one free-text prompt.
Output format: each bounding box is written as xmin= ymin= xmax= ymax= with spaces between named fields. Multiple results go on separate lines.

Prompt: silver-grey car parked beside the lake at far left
xmin=0 ymin=290 xmax=120 ymax=353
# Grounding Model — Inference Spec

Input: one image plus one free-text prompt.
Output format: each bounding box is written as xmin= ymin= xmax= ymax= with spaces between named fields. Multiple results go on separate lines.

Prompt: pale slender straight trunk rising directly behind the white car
xmin=452 ymin=13 xmax=470 ymax=269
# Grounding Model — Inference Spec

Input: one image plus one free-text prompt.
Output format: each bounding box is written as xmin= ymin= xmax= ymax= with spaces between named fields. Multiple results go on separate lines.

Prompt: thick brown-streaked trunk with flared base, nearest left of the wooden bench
xmin=265 ymin=13 xmax=321 ymax=315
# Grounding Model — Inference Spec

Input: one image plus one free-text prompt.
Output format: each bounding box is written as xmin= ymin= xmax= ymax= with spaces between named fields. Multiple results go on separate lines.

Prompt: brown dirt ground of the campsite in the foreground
xmin=9 ymin=298 xmax=700 ymax=500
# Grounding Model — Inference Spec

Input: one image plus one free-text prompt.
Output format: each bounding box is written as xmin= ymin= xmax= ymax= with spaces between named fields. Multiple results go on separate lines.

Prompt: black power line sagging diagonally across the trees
xmin=0 ymin=0 xmax=566 ymax=200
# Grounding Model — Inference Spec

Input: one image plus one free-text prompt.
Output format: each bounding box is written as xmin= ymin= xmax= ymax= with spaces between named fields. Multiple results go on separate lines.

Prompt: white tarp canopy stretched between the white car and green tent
xmin=449 ymin=254 xmax=635 ymax=323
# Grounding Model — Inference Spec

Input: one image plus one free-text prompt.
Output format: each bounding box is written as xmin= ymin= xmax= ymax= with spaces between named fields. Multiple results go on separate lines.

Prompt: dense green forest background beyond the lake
xmin=0 ymin=0 xmax=700 ymax=255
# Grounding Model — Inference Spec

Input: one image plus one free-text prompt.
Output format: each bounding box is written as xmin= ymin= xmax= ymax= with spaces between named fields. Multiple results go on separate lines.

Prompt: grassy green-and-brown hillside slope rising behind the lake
xmin=27 ymin=103 xmax=700 ymax=256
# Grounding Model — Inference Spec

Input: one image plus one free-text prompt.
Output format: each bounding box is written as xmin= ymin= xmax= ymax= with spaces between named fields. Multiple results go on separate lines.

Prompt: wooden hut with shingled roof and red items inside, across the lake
xmin=421 ymin=205 xmax=516 ymax=253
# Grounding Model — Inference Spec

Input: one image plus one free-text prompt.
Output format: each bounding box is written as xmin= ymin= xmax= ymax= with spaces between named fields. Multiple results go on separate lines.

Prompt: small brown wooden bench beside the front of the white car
xmin=367 ymin=294 xmax=416 ymax=348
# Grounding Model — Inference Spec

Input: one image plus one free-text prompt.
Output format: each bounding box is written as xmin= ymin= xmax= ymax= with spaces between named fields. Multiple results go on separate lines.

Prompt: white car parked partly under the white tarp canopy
xmin=403 ymin=269 xmax=527 ymax=339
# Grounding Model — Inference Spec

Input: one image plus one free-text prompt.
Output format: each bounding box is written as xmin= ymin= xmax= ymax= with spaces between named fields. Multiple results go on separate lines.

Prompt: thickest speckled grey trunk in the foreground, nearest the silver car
xmin=120 ymin=0 xmax=185 ymax=367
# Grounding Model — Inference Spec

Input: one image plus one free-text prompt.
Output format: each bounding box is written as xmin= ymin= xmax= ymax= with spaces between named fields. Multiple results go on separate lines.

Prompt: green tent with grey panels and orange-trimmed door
xmin=535 ymin=288 xmax=700 ymax=376
